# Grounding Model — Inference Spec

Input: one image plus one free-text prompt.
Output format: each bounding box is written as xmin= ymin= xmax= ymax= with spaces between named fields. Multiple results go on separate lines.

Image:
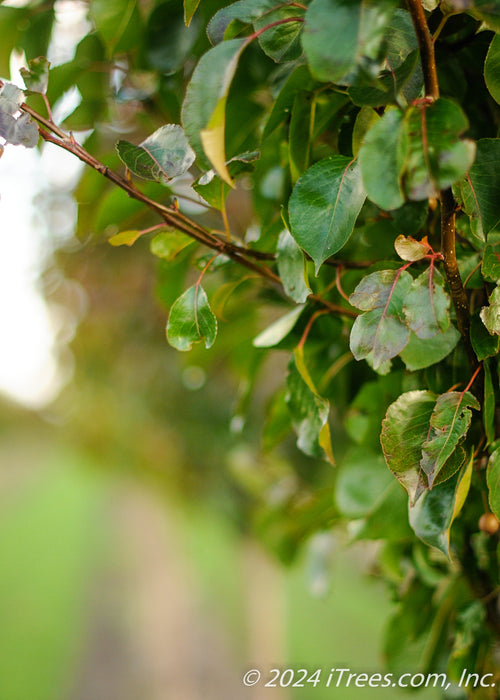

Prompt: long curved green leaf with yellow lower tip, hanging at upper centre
xmin=182 ymin=39 xmax=248 ymax=186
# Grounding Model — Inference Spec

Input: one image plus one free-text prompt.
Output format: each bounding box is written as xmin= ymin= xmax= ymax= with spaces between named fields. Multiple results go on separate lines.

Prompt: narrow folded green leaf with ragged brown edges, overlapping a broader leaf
xmin=420 ymin=391 xmax=481 ymax=488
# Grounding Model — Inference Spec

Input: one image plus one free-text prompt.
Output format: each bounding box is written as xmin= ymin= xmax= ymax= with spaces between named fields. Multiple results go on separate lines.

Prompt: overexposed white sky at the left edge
xmin=0 ymin=0 xmax=86 ymax=408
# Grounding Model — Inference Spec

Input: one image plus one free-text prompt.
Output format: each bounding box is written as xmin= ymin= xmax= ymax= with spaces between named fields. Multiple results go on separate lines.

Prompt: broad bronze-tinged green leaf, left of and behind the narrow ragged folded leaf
xmin=380 ymin=390 xmax=437 ymax=503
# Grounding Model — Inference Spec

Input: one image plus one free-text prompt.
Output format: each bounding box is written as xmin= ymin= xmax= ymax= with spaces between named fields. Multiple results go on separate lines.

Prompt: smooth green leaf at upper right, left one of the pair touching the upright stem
xmin=359 ymin=108 xmax=404 ymax=210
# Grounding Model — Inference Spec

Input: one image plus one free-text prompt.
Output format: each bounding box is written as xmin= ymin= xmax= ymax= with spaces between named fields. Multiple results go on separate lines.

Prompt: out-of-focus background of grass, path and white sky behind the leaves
xmin=0 ymin=1 xmax=435 ymax=700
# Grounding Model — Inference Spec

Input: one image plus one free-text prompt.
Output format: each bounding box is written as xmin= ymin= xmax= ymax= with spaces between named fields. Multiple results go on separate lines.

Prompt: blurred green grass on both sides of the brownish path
xmin=0 ymin=442 xmax=437 ymax=700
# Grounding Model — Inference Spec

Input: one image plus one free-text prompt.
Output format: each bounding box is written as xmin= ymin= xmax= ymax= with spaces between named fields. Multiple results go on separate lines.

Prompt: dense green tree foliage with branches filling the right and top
xmin=0 ymin=0 xmax=500 ymax=697
